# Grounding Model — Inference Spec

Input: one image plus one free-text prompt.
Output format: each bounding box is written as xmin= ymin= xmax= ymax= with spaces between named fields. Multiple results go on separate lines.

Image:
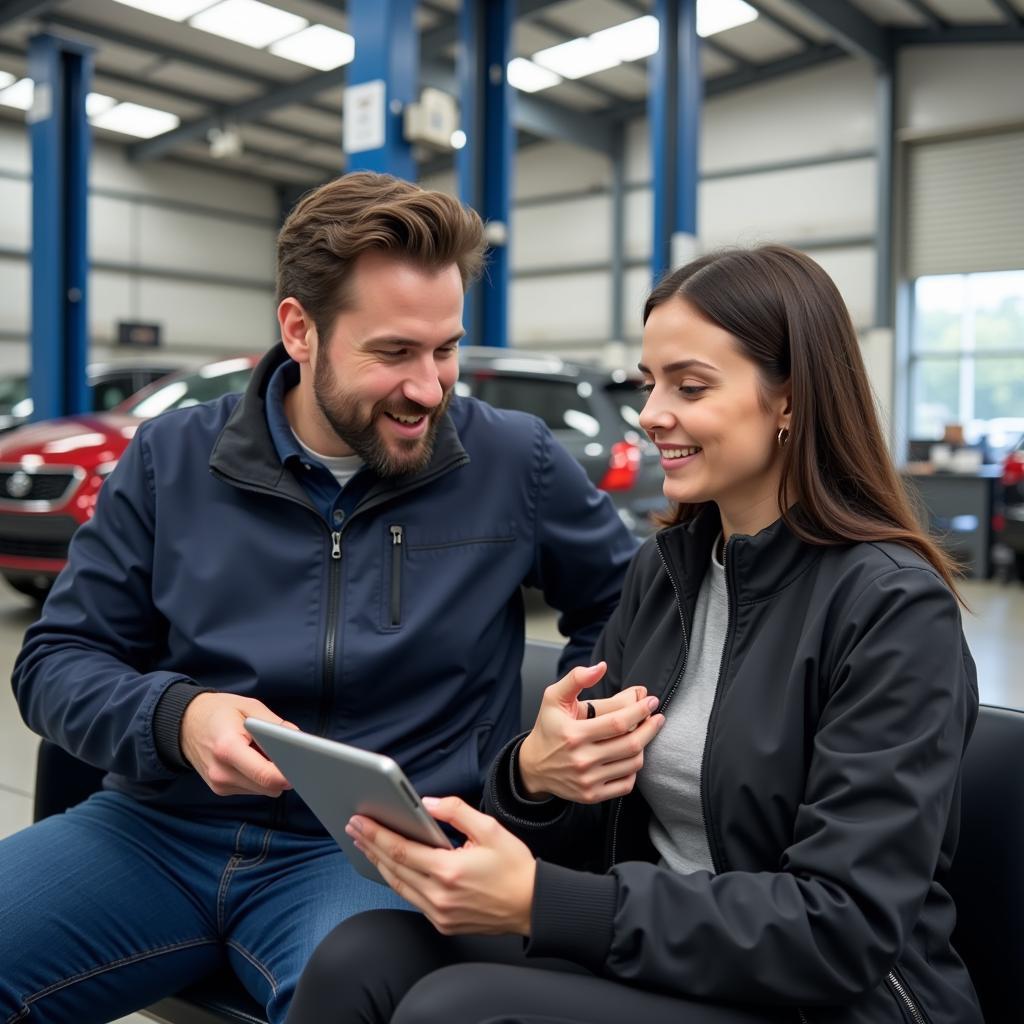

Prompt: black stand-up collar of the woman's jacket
xmin=657 ymin=503 xmax=823 ymax=609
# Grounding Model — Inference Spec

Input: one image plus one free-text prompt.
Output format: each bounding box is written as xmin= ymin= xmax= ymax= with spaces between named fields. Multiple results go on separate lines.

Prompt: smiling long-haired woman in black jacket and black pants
xmin=289 ymin=246 xmax=982 ymax=1024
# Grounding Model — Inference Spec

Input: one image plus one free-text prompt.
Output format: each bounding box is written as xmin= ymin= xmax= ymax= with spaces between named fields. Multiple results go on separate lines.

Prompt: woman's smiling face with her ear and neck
xmin=640 ymin=298 xmax=790 ymax=534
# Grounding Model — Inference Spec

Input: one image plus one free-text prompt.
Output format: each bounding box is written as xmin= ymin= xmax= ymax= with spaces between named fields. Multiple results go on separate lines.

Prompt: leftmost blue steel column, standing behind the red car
xmin=28 ymin=36 xmax=92 ymax=420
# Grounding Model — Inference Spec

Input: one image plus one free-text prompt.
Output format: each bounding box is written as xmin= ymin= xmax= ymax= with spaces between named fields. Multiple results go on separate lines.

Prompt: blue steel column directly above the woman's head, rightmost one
xmin=648 ymin=0 xmax=703 ymax=281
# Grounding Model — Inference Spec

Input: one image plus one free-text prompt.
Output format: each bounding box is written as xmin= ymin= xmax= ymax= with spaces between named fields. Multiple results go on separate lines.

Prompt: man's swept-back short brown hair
xmin=278 ymin=171 xmax=485 ymax=341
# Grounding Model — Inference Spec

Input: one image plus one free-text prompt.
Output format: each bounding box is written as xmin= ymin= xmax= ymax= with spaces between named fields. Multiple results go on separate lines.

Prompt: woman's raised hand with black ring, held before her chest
xmin=519 ymin=662 xmax=665 ymax=804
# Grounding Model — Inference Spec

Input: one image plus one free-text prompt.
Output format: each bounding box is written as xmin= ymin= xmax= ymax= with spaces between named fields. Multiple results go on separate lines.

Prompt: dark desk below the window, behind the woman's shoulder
xmin=902 ymin=466 xmax=1002 ymax=580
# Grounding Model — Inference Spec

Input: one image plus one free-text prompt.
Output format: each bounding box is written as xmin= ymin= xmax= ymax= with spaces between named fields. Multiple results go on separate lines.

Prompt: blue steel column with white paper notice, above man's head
xmin=346 ymin=0 xmax=420 ymax=181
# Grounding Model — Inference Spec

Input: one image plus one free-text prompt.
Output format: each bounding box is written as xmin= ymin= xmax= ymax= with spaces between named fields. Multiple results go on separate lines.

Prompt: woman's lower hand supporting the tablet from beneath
xmin=345 ymin=797 xmax=537 ymax=935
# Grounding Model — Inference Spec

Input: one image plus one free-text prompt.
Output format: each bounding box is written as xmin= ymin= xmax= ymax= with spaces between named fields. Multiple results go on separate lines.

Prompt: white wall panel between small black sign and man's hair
xmin=138 ymin=278 xmax=278 ymax=354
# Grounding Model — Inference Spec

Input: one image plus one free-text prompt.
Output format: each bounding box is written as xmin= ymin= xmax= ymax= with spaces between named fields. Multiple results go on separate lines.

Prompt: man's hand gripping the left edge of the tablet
xmin=181 ymin=693 xmax=296 ymax=797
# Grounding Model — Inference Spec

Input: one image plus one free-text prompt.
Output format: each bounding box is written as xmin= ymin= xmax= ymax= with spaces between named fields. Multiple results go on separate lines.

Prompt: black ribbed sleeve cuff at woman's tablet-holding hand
xmin=526 ymin=860 xmax=618 ymax=974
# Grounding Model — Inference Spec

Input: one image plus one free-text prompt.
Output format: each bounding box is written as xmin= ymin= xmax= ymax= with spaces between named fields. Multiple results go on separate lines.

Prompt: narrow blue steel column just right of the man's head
xmin=456 ymin=0 xmax=515 ymax=346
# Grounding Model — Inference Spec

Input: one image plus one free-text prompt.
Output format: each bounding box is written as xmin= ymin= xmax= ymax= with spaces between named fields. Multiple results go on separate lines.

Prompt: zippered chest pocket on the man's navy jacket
xmin=380 ymin=523 xmax=516 ymax=632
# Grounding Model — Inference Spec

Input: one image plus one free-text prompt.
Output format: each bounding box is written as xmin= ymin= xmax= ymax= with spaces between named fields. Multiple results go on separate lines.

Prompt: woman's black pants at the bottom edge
xmin=288 ymin=910 xmax=797 ymax=1024
